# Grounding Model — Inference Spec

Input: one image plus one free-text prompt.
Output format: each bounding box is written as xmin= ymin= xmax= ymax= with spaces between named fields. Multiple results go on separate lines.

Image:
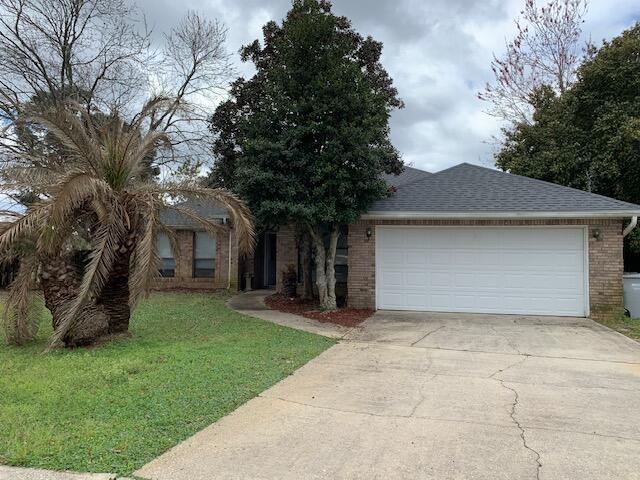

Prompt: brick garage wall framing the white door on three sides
xmin=348 ymin=219 xmax=623 ymax=318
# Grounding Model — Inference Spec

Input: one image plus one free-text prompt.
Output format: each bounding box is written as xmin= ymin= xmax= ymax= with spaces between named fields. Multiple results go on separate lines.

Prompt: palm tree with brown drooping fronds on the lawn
xmin=0 ymin=99 xmax=254 ymax=346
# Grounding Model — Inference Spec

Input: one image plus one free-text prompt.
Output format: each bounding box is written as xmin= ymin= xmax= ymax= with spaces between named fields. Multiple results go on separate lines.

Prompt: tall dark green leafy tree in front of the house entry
xmin=211 ymin=0 xmax=402 ymax=309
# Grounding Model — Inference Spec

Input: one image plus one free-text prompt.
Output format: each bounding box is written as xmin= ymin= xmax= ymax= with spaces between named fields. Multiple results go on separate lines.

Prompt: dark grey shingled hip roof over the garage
xmin=367 ymin=163 xmax=640 ymax=218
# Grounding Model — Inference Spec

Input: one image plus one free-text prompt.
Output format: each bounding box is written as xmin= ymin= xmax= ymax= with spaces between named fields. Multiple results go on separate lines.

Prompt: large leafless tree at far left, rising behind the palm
xmin=0 ymin=0 xmax=150 ymax=129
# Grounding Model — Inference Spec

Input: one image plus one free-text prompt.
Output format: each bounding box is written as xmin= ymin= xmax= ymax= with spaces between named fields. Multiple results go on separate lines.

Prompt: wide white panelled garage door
xmin=376 ymin=227 xmax=586 ymax=316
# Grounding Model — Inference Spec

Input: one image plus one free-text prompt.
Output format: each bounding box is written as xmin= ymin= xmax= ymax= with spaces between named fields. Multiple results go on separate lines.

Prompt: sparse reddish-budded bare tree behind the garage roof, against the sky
xmin=478 ymin=0 xmax=587 ymax=122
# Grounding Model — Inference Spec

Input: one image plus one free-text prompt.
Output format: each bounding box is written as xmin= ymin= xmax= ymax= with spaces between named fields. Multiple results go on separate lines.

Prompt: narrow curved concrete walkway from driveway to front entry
xmin=228 ymin=290 xmax=352 ymax=338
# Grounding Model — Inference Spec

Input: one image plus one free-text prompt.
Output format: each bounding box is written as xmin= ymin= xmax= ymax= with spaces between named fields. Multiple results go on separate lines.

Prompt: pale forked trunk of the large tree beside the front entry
xmin=309 ymin=225 xmax=340 ymax=311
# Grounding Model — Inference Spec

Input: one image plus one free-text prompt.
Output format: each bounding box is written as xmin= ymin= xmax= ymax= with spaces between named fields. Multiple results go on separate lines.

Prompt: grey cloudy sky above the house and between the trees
xmin=136 ymin=0 xmax=640 ymax=171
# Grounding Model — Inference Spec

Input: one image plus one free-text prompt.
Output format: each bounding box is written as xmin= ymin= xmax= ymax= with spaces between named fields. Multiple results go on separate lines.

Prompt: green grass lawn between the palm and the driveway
xmin=0 ymin=293 xmax=333 ymax=475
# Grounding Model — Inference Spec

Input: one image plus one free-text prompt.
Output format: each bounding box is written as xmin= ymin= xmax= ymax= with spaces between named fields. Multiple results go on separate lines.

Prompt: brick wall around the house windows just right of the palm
xmin=156 ymin=228 xmax=238 ymax=290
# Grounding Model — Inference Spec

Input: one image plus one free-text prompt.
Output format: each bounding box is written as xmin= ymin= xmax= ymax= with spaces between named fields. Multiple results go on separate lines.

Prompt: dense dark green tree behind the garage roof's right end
xmin=496 ymin=24 xmax=640 ymax=269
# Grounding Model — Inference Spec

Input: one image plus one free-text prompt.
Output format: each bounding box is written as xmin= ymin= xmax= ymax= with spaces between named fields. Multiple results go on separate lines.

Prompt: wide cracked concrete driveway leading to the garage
xmin=137 ymin=312 xmax=640 ymax=480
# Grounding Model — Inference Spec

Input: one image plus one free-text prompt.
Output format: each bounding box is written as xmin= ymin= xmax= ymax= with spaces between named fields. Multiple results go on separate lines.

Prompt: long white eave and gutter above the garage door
xmin=360 ymin=210 xmax=640 ymax=220
